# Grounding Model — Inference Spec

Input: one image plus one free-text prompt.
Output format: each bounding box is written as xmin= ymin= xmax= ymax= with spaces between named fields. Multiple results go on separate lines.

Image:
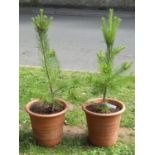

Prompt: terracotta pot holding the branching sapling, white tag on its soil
xmin=82 ymin=98 xmax=125 ymax=146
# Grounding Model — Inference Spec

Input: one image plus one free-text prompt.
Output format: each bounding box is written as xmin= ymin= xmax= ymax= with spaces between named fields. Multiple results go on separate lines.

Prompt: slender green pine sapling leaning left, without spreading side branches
xmin=32 ymin=9 xmax=63 ymax=107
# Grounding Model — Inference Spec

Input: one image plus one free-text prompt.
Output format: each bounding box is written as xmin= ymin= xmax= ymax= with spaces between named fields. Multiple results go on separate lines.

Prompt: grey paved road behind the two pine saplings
xmin=19 ymin=8 xmax=135 ymax=71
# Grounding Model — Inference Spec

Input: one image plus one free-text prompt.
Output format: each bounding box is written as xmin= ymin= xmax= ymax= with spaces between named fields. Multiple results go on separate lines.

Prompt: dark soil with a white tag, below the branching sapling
xmin=86 ymin=103 xmax=121 ymax=114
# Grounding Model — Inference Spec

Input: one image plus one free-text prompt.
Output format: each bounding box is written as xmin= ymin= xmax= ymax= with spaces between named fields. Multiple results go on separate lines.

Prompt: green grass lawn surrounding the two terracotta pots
xmin=19 ymin=67 xmax=135 ymax=155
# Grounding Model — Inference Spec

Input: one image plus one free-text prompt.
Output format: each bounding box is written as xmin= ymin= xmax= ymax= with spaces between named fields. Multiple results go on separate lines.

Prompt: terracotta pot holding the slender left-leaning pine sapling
xmin=26 ymin=99 xmax=68 ymax=147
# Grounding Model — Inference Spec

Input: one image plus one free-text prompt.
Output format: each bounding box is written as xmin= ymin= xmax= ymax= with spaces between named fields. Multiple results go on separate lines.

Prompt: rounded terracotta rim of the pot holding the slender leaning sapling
xmin=25 ymin=99 xmax=69 ymax=118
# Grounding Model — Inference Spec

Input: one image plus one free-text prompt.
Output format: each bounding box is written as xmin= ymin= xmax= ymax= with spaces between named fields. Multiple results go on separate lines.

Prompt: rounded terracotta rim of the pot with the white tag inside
xmin=82 ymin=98 xmax=126 ymax=117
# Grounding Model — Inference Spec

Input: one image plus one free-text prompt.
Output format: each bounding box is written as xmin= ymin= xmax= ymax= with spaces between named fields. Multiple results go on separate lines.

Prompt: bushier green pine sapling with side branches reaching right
xmin=94 ymin=9 xmax=131 ymax=103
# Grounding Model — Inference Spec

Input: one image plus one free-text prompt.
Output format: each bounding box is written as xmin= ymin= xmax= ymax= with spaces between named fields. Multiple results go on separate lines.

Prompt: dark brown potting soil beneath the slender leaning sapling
xmin=30 ymin=102 xmax=64 ymax=114
